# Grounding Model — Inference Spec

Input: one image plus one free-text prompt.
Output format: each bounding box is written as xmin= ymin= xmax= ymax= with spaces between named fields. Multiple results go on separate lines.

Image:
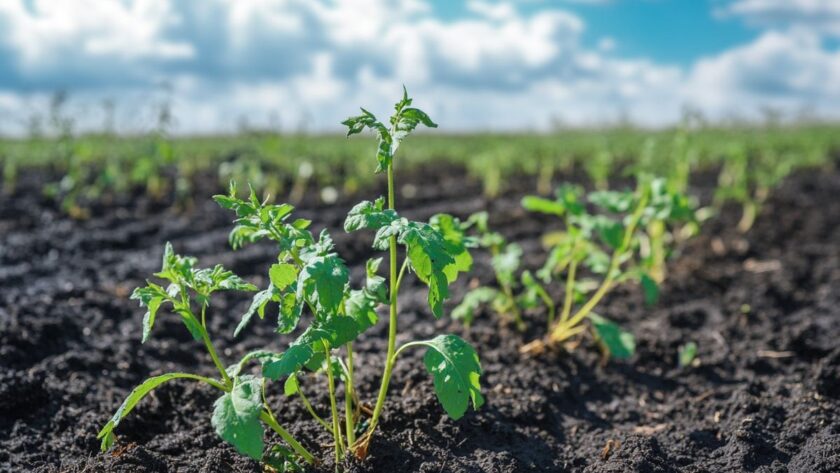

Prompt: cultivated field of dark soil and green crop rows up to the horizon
xmin=0 ymin=125 xmax=840 ymax=473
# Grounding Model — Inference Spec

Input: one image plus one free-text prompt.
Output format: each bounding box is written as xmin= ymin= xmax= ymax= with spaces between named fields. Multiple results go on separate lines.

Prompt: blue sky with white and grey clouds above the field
xmin=0 ymin=0 xmax=840 ymax=134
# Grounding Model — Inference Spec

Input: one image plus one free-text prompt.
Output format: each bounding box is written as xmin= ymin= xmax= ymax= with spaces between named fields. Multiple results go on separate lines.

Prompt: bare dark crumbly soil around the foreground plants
xmin=0 ymin=163 xmax=840 ymax=473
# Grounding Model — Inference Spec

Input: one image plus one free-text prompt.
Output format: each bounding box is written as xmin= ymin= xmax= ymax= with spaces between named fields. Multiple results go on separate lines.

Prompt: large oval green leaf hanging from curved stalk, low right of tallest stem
xmin=420 ymin=335 xmax=484 ymax=420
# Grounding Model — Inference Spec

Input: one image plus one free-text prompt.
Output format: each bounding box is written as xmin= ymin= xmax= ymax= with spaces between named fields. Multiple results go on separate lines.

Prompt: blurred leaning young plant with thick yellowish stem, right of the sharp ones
xmin=522 ymin=177 xmax=693 ymax=358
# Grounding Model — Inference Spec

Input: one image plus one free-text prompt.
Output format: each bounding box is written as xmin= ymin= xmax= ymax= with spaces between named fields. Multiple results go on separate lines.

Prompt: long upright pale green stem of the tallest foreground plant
xmin=362 ymin=163 xmax=399 ymax=451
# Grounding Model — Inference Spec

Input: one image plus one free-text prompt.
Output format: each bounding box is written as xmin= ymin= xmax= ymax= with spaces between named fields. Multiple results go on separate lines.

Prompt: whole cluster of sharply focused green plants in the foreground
xmin=99 ymin=92 xmax=484 ymax=470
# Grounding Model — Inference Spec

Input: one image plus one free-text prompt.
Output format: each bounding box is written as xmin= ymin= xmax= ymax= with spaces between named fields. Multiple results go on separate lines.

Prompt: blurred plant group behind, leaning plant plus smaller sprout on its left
xmin=460 ymin=176 xmax=695 ymax=358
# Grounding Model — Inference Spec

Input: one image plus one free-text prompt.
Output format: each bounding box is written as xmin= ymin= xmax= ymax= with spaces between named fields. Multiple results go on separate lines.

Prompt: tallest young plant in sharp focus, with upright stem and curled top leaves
xmin=343 ymin=89 xmax=484 ymax=458
